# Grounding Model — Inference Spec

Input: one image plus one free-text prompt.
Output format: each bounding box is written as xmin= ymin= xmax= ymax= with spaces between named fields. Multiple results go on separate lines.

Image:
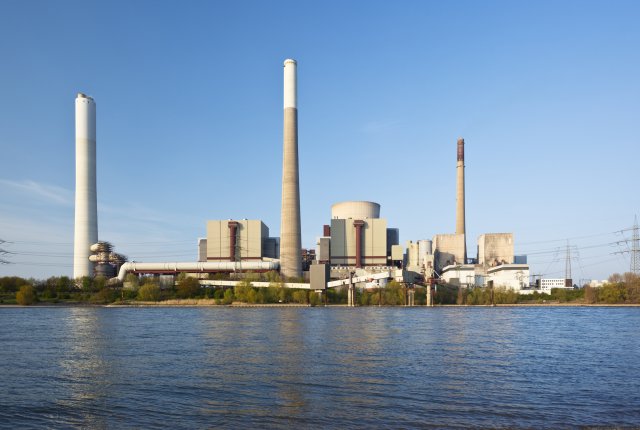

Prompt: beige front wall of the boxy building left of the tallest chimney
xmin=207 ymin=220 xmax=269 ymax=261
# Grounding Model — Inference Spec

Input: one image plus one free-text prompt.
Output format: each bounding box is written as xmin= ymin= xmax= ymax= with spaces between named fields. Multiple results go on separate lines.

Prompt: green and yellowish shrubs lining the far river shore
xmin=0 ymin=272 xmax=640 ymax=306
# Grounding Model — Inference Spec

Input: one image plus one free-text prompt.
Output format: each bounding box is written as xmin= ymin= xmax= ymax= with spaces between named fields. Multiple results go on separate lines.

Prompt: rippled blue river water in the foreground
xmin=0 ymin=307 xmax=640 ymax=429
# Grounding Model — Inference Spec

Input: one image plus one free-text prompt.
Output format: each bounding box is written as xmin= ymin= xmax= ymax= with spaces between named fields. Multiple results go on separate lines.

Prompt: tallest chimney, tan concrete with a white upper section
xmin=280 ymin=60 xmax=302 ymax=277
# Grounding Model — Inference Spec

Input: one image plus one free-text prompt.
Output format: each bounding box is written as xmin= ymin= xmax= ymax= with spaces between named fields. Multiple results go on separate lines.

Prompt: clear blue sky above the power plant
xmin=0 ymin=0 xmax=640 ymax=279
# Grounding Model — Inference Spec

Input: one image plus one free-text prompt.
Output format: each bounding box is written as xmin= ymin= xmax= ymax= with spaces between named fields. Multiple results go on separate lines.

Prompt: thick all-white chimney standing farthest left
xmin=73 ymin=93 xmax=98 ymax=279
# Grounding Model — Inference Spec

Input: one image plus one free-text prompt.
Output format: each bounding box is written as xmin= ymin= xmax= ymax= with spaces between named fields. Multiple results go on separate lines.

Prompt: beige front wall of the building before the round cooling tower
xmin=330 ymin=218 xmax=387 ymax=266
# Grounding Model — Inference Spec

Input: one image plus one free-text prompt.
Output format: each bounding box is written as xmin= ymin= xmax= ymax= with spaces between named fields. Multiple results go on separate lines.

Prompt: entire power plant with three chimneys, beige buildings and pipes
xmin=74 ymin=59 xmax=544 ymax=298
